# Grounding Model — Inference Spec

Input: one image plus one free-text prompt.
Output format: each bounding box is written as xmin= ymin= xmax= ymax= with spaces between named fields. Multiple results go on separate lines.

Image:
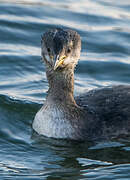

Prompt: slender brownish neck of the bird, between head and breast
xmin=46 ymin=68 xmax=76 ymax=104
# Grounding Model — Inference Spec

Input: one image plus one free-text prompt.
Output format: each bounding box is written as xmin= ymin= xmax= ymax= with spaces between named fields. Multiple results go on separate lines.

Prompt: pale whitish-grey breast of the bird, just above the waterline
xmin=33 ymin=106 xmax=74 ymax=138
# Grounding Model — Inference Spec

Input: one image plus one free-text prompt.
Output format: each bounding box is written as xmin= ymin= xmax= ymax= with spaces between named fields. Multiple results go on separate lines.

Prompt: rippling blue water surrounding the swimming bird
xmin=0 ymin=0 xmax=130 ymax=180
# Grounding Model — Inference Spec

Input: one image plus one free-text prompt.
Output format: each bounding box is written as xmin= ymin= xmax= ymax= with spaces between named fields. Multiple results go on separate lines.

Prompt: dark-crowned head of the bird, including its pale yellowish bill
xmin=41 ymin=28 xmax=81 ymax=71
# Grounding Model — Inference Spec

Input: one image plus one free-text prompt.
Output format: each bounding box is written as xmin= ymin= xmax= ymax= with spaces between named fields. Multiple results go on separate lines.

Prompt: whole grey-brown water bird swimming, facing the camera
xmin=33 ymin=29 xmax=130 ymax=140
